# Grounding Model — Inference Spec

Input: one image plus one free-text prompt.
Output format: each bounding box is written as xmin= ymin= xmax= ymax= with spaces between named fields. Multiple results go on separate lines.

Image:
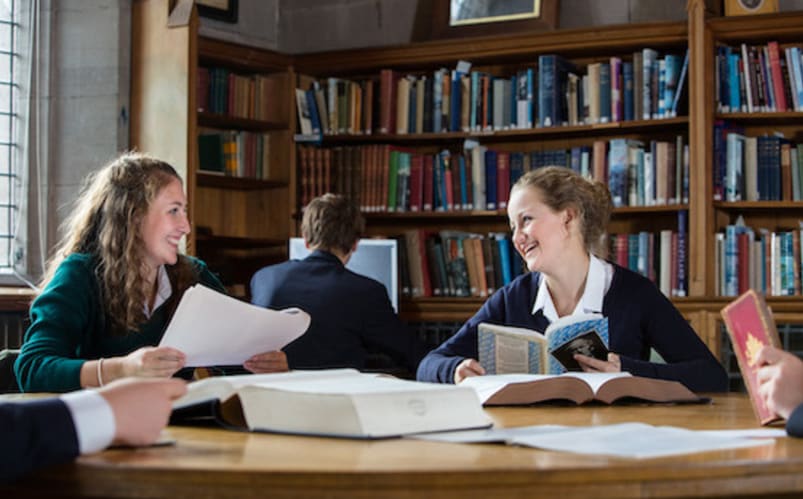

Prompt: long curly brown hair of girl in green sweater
xmin=42 ymin=152 xmax=193 ymax=334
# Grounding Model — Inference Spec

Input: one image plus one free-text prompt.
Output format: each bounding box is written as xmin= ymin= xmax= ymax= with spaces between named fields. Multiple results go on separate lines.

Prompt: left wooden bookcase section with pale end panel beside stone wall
xmin=131 ymin=0 xmax=296 ymax=297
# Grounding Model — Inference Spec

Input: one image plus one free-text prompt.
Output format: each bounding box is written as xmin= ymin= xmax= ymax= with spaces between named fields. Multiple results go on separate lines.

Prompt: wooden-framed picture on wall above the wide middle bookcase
xmin=432 ymin=0 xmax=558 ymax=38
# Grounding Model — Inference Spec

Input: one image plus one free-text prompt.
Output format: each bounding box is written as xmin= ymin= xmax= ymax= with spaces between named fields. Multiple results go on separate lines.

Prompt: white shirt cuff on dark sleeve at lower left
xmin=60 ymin=390 xmax=116 ymax=454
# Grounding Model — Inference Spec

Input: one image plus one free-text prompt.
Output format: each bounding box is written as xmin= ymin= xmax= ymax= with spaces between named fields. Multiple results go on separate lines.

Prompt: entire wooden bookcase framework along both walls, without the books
xmin=131 ymin=0 xmax=803 ymax=360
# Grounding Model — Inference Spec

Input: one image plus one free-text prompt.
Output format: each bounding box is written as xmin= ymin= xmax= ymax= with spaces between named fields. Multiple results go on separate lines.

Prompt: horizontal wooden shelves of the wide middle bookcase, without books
xmin=295 ymin=17 xmax=696 ymax=321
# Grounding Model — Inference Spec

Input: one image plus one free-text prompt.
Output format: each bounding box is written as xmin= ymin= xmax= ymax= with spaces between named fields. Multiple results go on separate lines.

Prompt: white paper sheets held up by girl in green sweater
xmin=159 ymin=285 xmax=310 ymax=367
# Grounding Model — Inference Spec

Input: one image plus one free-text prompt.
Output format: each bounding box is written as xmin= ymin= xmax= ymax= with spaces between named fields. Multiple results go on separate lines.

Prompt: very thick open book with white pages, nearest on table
xmin=170 ymin=369 xmax=491 ymax=438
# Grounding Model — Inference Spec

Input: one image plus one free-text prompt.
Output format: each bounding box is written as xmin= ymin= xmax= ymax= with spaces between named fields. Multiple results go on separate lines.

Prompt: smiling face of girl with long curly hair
xmin=141 ymin=178 xmax=190 ymax=269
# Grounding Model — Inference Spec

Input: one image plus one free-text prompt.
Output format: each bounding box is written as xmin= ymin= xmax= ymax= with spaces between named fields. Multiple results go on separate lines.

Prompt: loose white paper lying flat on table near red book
xmin=508 ymin=423 xmax=775 ymax=459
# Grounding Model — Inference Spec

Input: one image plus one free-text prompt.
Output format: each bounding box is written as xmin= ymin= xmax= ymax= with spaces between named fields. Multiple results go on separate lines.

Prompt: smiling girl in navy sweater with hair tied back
xmin=417 ymin=167 xmax=727 ymax=392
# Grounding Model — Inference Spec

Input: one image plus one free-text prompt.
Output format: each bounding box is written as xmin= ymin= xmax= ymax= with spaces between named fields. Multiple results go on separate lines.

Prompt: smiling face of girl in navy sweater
xmin=507 ymin=186 xmax=577 ymax=275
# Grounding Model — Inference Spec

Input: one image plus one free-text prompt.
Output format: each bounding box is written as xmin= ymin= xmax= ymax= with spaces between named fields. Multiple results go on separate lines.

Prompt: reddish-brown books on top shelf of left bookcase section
xmin=196 ymin=66 xmax=286 ymax=121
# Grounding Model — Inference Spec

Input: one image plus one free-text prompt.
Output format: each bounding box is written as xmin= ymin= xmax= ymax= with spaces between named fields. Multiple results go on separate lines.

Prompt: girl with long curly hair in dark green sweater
xmin=14 ymin=153 xmax=287 ymax=392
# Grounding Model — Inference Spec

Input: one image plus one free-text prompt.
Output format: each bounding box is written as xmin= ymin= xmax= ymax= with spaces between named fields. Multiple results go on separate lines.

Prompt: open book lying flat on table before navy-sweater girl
xmin=460 ymin=372 xmax=708 ymax=405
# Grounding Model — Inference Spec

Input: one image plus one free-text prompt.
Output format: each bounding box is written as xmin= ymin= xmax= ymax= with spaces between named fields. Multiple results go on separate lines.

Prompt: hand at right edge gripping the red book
xmin=756 ymin=346 xmax=803 ymax=437
